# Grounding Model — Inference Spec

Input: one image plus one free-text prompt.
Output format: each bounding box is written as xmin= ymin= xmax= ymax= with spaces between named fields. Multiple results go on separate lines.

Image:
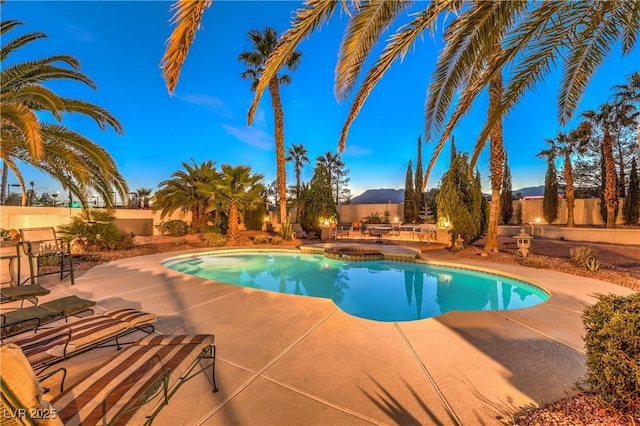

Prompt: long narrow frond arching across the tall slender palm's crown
xmin=247 ymin=0 xmax=344 ymax=125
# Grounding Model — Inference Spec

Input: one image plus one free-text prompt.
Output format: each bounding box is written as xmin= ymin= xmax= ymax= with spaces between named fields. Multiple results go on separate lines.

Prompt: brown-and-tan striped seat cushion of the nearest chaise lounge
xmin=51 ymin=339 xmax=215 ymax=426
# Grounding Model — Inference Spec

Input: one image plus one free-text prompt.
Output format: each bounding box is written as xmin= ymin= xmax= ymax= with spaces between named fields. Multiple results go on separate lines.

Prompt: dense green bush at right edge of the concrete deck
xmin=582 ymin=293 xmax=640 ymax=416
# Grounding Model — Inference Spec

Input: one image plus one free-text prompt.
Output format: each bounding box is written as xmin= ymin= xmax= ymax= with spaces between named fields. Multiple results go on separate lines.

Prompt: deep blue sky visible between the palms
xmin=2 ymin=0 xmax=639 ymax=201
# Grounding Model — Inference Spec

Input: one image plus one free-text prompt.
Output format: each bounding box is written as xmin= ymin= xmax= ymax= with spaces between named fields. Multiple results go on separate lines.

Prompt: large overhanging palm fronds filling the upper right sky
xmin=249 ymin=0 xmax=640 ymax=166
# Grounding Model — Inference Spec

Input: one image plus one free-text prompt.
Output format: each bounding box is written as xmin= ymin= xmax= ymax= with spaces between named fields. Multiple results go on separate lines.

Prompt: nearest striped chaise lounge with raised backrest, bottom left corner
xmin=0 ymin=335 xmax=218 ymax=426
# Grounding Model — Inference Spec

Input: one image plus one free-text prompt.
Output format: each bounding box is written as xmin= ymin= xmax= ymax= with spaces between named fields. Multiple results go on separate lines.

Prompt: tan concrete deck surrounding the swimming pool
xmin=26 ymin=245 xmax=633 ymax=425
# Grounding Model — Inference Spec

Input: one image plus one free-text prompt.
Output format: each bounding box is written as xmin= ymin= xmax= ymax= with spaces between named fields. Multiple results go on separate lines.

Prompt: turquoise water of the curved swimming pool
xmin=164 ymin=252 xmax=549 ymax=321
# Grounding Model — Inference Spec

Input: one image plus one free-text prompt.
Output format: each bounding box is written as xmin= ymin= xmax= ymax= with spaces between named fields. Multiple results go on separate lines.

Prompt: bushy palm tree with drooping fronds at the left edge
xmin=0 ymin=20 xmax=128 ymax=205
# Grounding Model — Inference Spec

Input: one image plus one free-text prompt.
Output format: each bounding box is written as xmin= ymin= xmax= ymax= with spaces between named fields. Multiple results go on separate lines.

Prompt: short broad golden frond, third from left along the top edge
xmin=334 ymin=0 xmax=411 ymax=101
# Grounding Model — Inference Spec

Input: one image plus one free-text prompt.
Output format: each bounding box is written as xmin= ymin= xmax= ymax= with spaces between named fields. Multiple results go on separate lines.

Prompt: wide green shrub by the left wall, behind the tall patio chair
xmin=58 ymin=209 xmax=134 ymax=252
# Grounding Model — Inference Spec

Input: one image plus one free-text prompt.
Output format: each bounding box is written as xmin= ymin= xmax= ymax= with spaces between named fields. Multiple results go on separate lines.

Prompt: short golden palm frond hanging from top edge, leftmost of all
xmin=160 ymin=0 xmax=213 ymax=94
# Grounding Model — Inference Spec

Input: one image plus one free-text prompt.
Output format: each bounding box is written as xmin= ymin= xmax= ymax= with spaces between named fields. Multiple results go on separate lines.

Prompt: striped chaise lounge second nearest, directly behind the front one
xmin=4 ymin=308 xmax=156 ymax=372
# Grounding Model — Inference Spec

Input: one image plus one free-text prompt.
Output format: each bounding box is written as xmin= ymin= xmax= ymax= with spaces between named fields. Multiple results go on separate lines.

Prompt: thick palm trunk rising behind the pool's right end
xmin=484 ymin=62 xmax=504 ymax=251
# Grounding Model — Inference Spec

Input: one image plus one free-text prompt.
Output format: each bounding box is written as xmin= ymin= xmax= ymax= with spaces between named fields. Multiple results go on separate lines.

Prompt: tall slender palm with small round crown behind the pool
xmin=238 ymin=27 xmax=302 ymax=225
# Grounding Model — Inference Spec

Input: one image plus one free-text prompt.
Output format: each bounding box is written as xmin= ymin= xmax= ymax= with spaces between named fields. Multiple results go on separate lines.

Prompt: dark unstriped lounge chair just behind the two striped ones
xmin=0 ymin=296 xmax=96 ymax=338
